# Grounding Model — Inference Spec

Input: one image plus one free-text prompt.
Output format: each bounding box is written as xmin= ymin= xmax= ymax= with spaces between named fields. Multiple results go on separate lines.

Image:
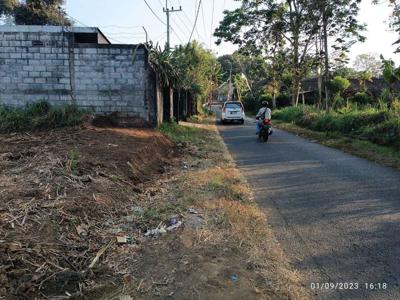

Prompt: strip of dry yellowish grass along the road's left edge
xmin=168 ymin=120 xmax=309 ymax=299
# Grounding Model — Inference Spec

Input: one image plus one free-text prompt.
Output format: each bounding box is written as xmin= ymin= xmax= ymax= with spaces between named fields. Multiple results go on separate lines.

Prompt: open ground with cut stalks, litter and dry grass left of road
xmin=0 ymin=115 xmax=308 ymax=299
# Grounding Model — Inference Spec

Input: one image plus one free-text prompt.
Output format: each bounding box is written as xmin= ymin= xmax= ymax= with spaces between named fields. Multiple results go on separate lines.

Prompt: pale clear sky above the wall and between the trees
xmin=66 ymin=0 xmax=400 ymax=62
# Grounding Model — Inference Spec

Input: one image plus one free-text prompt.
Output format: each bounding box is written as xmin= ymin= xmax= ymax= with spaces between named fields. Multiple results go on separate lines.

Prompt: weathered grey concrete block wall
xmin=0 ymin=26 xmax=157 ymax=123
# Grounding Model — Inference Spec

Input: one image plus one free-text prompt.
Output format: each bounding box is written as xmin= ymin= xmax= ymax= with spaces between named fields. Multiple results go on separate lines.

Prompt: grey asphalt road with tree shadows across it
xmin=218 ymin=116 xmax=400 ymax=299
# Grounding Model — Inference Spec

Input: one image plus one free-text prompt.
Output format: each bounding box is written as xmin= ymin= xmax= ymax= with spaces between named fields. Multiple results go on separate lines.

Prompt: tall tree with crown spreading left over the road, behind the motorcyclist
xmin=215 ymin=0 xmax=318 ymax=105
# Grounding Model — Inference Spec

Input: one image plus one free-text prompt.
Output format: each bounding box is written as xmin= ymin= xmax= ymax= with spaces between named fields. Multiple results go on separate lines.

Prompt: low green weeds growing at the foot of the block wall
xmin=0 ymin=101 xmax=88 ymax=132
